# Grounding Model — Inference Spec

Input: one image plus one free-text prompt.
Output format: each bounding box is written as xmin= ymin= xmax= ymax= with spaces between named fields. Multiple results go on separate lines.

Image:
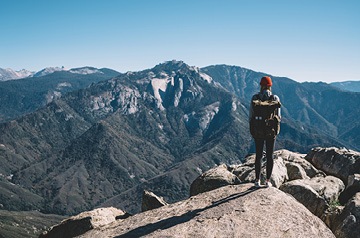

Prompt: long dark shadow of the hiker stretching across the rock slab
xmin=116 ymin=186 xmax=259 ymax=238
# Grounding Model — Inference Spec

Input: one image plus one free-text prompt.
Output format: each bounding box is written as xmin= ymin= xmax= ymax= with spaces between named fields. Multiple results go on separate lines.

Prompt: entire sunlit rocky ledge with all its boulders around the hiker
xmin=42 ymin=148 xmax=360 ymax=238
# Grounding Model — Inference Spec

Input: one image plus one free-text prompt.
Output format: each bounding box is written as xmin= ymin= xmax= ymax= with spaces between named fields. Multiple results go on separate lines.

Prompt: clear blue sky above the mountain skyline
xmin=0 ymin=0 xmax=360 ymax=82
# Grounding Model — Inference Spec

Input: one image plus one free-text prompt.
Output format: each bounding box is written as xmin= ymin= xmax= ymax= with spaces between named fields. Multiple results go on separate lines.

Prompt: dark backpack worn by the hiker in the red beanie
xmin=250 ymin=95 xmax=281 ymax=139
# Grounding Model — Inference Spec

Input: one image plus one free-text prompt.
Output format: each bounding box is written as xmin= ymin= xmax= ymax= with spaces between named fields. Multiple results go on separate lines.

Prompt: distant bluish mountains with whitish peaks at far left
xmin=0 ymin=67 xmax=120 ymax=122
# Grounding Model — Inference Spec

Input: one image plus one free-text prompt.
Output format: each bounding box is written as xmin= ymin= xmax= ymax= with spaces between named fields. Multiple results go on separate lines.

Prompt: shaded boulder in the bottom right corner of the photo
xmin=333 ymin=193 xmax=360 ymax=238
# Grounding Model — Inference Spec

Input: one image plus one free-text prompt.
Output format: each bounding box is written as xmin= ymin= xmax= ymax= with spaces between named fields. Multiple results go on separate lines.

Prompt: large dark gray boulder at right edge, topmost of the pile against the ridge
xmin=305 ymin=147 xmax=360 ymax=184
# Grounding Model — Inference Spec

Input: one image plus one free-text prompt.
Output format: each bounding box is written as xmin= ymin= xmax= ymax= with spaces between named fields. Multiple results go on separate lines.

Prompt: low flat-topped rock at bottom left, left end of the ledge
xmin=39 ymin=207 xmax=126 ymax=238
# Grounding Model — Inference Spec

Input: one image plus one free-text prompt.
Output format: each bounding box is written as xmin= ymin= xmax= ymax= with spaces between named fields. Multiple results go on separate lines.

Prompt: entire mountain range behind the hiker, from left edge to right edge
xmin=0 ymin=61 xmax=360 ymax=220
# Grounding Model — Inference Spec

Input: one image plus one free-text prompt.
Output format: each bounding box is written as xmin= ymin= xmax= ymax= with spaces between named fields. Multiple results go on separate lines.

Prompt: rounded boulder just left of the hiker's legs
xmin=190 ymin=164 xmax=240 ymax=196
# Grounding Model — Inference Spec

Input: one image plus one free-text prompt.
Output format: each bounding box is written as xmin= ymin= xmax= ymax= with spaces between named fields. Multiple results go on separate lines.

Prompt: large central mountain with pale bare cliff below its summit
xmin=1 ymin=63 xmax=249 ymax=214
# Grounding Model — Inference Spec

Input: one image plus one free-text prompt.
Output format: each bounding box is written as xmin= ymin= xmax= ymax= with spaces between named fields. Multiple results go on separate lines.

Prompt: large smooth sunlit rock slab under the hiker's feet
xmin=80 ymin=184 xmax=335 ymax=238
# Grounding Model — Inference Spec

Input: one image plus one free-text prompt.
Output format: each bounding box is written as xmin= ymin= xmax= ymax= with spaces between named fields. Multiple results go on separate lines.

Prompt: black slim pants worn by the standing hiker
xmin=255 ymin=138 xmax=275 ymax=180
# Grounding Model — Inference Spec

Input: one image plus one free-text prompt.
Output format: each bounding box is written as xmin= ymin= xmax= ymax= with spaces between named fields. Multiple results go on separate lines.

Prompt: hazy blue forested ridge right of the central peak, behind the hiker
xmin=202 ymin=65 xmax=360 ymax=152
